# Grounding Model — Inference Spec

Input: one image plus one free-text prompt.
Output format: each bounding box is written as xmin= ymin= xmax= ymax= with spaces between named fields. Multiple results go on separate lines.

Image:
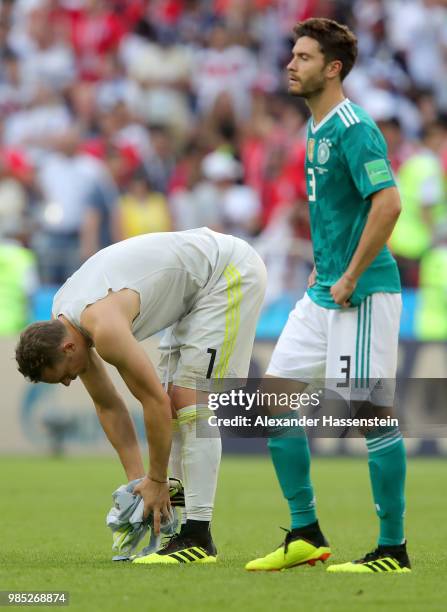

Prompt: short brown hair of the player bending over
xmin=16 ymin=319 xmax=67 ymax=382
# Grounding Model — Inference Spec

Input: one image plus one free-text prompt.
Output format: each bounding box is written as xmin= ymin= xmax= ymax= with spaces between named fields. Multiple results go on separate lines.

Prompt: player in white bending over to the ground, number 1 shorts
xmin=16 ymin=228 xmax=266 ymax=564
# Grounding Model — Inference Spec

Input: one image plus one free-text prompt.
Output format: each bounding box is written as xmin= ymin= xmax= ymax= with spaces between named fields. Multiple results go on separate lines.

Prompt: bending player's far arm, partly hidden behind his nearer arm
xmin=80 ymin=349 xmax=144 ymax=480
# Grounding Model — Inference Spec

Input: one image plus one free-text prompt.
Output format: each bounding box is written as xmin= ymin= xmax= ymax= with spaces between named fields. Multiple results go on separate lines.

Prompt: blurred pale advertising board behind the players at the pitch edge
xmin=0 ymin=339 xmax=447 ymax=456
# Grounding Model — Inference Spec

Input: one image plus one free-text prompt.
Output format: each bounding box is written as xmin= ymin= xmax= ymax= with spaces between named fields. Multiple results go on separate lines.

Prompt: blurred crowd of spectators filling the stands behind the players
xmin=0 ymin=0 xmax=447 ymax=340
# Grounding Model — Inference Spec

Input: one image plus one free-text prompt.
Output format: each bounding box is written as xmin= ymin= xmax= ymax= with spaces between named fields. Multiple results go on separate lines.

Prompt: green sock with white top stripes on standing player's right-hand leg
xmin=366 ymin=428 xmax=406 ymax=546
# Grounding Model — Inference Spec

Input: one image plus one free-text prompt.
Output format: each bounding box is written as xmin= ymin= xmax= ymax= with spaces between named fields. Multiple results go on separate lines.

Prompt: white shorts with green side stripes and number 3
xmin=267 ymin=293 xmax=402 ymax=406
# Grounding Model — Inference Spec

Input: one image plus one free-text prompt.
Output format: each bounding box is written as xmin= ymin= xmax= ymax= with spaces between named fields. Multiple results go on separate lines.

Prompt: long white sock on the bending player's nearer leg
xmin=177 ymin=405 xmax=222 ymax=521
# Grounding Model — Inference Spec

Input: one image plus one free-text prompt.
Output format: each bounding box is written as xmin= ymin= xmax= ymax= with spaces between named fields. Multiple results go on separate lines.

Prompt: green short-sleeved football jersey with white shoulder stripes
xmin=306 ymin=99 xmax=400 ymax=308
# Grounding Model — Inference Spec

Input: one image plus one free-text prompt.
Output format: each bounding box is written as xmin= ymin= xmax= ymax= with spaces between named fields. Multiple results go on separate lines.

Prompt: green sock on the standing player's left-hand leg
xmin=268 ymin=415 xmax=317 ymax=529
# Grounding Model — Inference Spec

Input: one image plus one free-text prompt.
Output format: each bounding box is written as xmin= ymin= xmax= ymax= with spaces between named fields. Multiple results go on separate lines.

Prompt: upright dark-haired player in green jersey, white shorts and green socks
xmin=246 ymin=18 xmax=410 ymax=573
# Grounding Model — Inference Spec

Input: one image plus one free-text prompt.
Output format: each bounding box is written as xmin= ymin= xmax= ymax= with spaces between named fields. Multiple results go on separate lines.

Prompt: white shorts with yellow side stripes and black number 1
xmin=158 ymin=242 xmax=267 ymax=391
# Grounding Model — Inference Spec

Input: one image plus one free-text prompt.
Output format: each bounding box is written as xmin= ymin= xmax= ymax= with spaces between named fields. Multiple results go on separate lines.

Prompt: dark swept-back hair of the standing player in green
xmin=293 ymin=17 xmax=357 ymax=81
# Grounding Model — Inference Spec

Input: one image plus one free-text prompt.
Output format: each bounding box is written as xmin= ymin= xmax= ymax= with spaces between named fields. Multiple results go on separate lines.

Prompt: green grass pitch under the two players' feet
xmin=0 ymin=457 xmax=447 ymax=612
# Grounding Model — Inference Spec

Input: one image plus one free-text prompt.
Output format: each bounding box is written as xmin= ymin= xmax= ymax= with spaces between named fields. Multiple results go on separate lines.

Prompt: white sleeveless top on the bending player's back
xmin=52 ymin=228 xmax=240 ymax=340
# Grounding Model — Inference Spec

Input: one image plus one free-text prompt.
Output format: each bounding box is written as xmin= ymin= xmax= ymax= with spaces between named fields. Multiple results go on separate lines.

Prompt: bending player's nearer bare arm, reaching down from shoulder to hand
xmin=93 ymin=313 xmax=171 ymax=532
